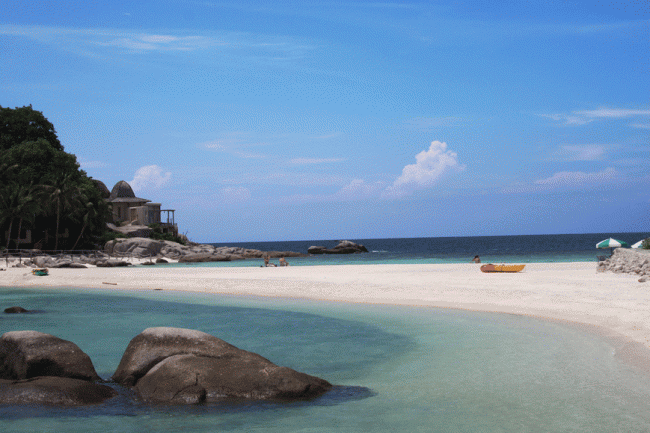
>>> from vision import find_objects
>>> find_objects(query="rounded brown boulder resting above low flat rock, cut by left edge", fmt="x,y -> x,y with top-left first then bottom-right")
0,331 -> 100,380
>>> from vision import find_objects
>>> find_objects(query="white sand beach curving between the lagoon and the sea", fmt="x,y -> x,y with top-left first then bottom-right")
0,263 -> 650,361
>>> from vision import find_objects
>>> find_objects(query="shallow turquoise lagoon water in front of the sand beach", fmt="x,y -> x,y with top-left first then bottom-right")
0,288 -> 650,432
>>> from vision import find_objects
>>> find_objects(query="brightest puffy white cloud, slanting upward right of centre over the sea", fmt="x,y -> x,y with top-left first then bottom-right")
382,141 -> 464,198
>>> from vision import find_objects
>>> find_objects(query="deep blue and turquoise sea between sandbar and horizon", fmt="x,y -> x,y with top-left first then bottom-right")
153,233 -> 650,267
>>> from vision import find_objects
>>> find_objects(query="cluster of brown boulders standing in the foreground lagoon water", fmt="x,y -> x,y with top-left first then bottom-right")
0,327 -> 332,406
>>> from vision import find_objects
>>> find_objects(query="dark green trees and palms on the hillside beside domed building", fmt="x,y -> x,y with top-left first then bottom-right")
0,107 -> 110,249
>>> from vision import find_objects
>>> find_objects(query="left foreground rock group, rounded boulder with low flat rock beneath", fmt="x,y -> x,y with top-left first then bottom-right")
0,331 -> 117,406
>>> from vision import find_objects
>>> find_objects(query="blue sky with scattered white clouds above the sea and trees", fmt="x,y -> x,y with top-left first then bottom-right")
0,0 -> 650,242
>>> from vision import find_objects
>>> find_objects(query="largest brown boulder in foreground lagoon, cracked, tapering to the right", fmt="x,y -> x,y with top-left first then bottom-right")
113,328 -> 332,404
